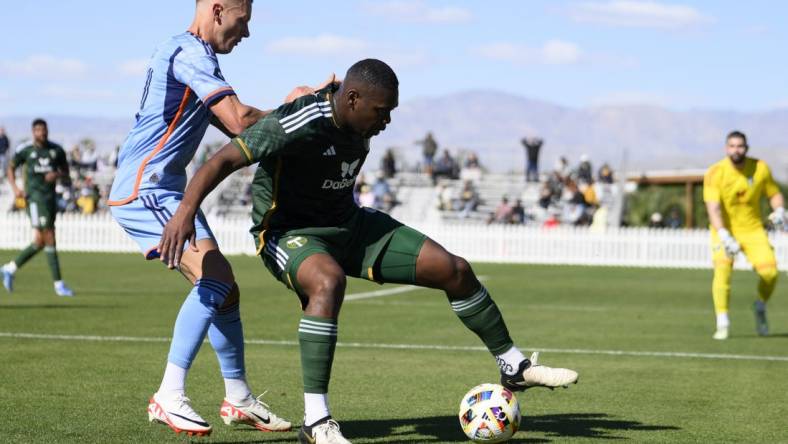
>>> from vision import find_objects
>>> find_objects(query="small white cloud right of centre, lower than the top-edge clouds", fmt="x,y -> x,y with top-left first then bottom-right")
471,40 -> 584,65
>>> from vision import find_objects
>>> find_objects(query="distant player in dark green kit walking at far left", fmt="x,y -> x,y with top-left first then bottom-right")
3,119 -> 74,296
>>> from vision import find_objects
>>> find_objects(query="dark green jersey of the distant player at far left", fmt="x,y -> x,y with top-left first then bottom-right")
11,142 -> 68,200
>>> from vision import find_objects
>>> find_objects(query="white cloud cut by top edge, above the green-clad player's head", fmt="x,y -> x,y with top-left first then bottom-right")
363,0 -> 473,23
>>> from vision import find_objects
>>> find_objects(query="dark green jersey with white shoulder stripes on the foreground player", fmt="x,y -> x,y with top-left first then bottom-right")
233,86 -> 369,250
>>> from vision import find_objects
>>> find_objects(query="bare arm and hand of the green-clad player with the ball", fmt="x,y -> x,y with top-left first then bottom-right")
158,143 -> 247,268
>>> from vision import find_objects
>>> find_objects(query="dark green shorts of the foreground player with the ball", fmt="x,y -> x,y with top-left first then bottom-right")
260,208 -> 427,302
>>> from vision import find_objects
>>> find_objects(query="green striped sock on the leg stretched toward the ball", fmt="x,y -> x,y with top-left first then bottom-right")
450,286 -> 514,356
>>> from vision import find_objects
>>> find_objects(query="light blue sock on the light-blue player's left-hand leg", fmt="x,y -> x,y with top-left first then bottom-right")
167,279 -> 230,369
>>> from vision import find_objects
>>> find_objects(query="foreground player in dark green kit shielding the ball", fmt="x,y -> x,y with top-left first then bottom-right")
159,59 -> 577,444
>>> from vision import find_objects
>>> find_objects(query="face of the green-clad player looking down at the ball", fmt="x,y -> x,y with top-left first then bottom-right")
349,88 -> 399,138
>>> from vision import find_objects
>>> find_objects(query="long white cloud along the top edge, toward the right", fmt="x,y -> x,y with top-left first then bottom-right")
566,0 -> 714,29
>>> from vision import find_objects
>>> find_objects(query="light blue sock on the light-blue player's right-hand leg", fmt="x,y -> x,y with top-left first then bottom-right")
208,286 -> 246,379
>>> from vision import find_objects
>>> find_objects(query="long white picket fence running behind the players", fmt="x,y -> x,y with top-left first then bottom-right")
0,213 -> 788,270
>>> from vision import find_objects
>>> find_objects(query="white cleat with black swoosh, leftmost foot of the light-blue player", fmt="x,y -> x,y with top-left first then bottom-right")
148,393 -> 212,436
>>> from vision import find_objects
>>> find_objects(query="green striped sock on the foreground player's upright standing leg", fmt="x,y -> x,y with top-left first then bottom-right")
298,315 -> 337,393
